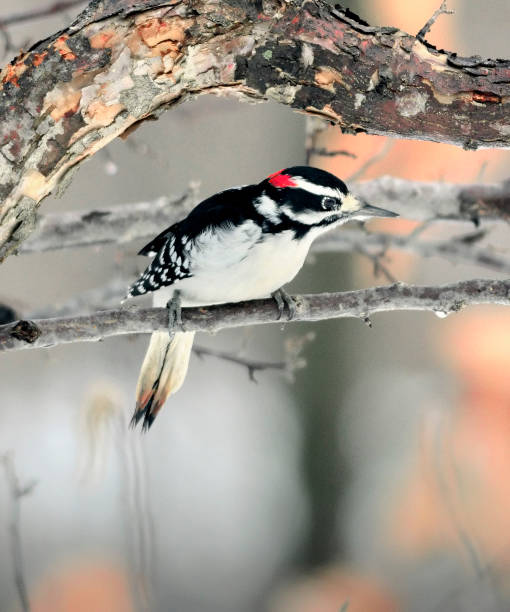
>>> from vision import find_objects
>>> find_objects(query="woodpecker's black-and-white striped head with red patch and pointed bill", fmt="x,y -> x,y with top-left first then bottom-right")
257,166 -> 398,226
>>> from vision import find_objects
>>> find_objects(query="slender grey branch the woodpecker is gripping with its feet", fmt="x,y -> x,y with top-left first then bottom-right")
0,279 -> 510,351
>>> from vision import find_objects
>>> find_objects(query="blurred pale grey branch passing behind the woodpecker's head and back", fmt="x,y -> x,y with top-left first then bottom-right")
19,176 -> 510,253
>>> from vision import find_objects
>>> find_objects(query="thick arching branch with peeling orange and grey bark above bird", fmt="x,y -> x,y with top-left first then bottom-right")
0,0 -> 510,259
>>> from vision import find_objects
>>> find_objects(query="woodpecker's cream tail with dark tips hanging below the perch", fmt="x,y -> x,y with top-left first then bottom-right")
131,332 -> 195,429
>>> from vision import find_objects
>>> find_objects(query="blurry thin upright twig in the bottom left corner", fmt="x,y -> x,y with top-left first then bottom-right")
1,453 -> 36,612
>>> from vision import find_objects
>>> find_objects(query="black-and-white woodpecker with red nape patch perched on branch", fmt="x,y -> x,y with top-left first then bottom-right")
128,166 -> 397,429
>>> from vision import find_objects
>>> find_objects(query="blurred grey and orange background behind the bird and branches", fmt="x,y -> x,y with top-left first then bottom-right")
0,0 -> 510,612
